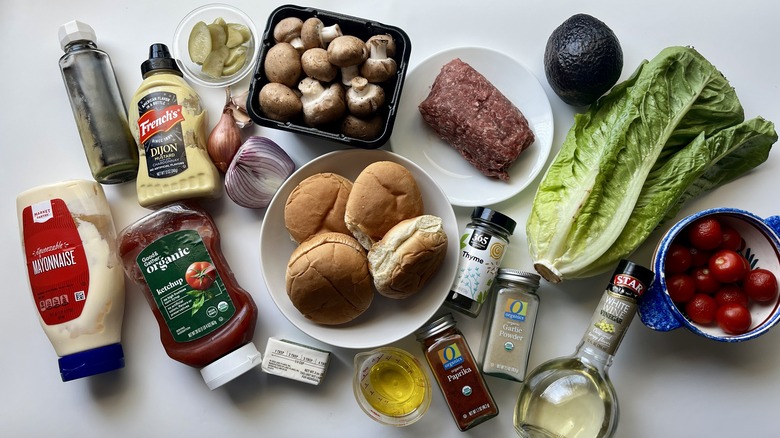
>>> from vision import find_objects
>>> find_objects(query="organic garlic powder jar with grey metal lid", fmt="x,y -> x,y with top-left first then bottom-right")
479,268 -> 541,382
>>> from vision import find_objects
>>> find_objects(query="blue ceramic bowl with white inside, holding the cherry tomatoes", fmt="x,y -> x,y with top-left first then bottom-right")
639,208 -> 780,342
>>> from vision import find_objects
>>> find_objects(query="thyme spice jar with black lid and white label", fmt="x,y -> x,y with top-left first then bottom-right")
444,207 -> 517,318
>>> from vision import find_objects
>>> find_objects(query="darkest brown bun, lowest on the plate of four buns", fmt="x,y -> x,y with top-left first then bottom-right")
285,232 -> 374,325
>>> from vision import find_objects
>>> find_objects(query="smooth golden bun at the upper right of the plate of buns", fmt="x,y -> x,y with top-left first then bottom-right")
344,161 -> 424,250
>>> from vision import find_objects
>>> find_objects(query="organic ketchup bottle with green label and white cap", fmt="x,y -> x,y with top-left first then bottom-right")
119,202 -> 261,389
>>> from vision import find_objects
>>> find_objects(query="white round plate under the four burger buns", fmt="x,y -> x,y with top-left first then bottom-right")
260,149 -> 458,349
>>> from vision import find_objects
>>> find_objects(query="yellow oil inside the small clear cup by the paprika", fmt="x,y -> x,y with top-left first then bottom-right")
362,360 -> 426,417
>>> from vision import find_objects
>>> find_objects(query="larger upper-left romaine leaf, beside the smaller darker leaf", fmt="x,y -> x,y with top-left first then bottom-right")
526,47 -> 756,282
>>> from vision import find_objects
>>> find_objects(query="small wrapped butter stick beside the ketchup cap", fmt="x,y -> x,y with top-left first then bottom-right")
262,338 -> 330,385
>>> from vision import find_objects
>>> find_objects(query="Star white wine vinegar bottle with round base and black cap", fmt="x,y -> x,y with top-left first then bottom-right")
514,260 -> 653,438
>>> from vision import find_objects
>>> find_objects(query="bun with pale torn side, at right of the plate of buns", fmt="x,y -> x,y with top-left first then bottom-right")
368,215 -> 447,299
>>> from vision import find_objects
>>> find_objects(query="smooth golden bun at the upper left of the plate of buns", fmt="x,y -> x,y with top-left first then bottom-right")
284,172 -> 352,243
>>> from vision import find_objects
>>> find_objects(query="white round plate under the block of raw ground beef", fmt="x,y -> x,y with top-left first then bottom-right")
390,47 -> 553,207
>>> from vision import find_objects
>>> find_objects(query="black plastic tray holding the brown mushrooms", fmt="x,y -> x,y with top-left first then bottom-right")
247,5 -> 412,149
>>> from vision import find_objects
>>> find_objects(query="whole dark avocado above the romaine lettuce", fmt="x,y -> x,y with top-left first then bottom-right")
544,14 -> 623,106
